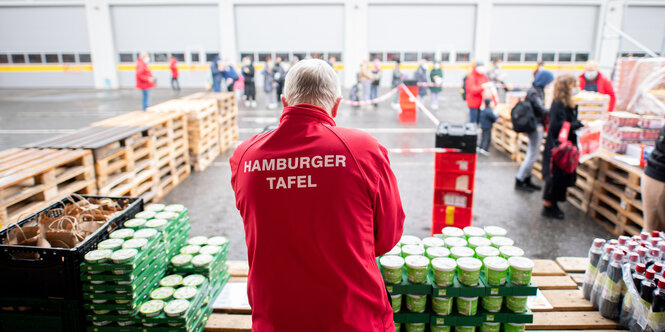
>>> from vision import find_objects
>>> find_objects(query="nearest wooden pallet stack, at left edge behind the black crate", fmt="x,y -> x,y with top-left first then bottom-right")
0,148 -> 97,228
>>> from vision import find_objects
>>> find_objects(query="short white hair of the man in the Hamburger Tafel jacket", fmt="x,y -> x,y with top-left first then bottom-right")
284,59 -> 342,112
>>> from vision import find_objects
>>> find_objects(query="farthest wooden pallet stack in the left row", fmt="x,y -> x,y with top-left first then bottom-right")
184,92 -> 238,153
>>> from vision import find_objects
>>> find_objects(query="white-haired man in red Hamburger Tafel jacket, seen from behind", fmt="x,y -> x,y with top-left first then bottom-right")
230,59 -> 404,332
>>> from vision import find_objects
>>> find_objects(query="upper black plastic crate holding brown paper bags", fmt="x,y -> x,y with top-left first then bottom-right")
0,195 -> 143,301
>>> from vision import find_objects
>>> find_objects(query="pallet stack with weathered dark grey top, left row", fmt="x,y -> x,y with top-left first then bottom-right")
27,126 -> 158,201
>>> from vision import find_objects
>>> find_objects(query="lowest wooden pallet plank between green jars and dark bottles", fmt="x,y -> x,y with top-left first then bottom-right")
526,311 -> 619,330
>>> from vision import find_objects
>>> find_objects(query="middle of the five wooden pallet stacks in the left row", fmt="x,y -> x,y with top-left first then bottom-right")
93,111 -> 191,200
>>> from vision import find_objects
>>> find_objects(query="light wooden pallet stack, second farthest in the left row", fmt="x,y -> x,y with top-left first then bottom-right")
148,99 -> 220,171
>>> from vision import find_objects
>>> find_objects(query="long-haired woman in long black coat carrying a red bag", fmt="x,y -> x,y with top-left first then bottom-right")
542,74 -> 584,219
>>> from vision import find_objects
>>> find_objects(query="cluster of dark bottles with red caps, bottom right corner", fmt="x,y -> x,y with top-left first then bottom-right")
582,231 -> 665,331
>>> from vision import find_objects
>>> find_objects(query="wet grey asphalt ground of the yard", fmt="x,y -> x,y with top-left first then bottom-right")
0,89 -> 610,259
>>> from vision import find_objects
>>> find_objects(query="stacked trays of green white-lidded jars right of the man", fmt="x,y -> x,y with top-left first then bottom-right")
378,226 -> 537,332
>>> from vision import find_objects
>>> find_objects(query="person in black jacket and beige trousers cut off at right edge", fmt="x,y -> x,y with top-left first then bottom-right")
642,127 -> 665,232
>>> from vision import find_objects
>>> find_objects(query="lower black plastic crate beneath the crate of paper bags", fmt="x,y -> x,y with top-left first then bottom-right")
0,298 -> 86,332
